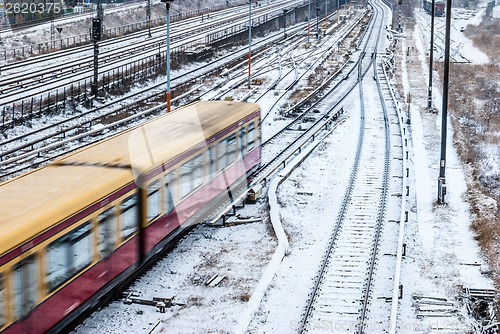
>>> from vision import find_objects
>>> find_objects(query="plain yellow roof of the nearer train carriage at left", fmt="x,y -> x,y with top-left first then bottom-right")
0,165 -> 132,256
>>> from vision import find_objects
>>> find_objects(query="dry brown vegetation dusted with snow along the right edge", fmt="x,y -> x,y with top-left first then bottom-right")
434,14 -> 500,298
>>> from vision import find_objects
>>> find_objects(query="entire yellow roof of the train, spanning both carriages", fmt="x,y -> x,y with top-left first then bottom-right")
0,101 -> 259,256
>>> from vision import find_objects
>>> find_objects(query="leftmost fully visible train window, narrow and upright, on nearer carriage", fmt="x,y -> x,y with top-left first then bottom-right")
12,255 -> 38,319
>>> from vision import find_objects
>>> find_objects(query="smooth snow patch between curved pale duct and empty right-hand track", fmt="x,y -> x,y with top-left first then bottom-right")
248,104 -> 359,333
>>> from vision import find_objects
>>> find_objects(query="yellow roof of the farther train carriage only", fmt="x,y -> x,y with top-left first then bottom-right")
58,101 -> 259,173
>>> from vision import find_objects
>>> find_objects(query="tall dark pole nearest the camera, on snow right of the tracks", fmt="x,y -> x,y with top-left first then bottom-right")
438,0 -> 451,204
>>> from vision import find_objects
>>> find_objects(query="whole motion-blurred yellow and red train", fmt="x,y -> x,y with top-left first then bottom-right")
0,101 -> 261,333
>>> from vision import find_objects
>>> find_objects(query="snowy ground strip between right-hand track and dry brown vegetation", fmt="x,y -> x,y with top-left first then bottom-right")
394,5 -> 493,332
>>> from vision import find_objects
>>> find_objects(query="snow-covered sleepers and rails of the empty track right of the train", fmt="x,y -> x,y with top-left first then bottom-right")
298,71 -> 390,333
